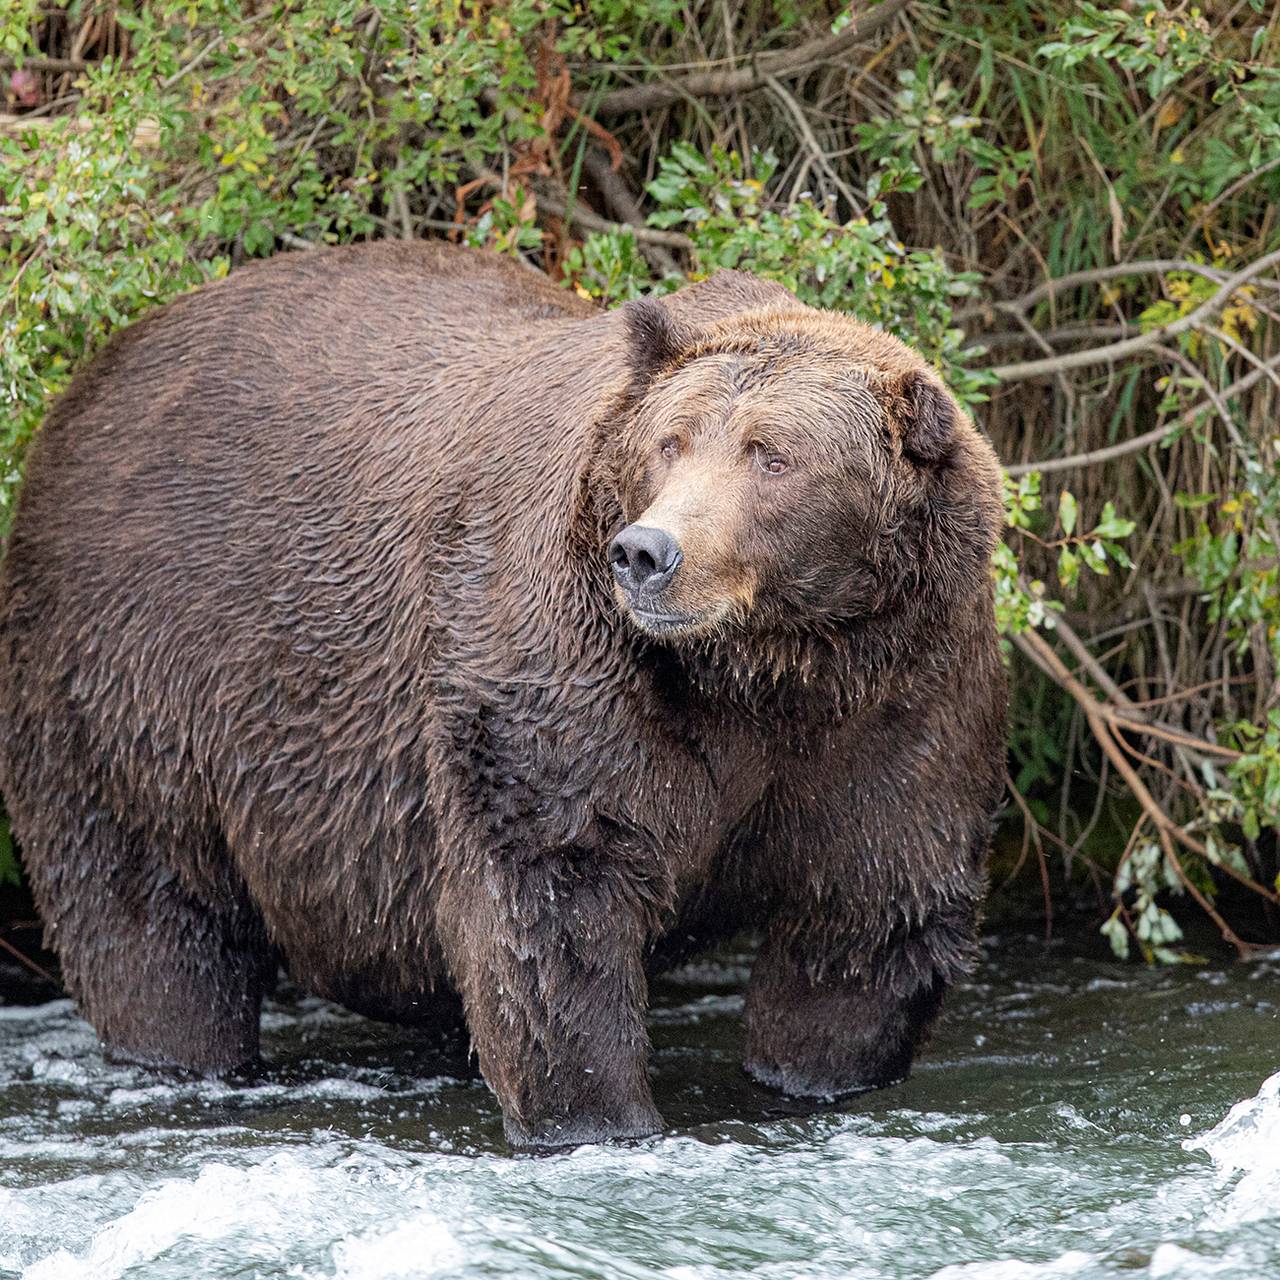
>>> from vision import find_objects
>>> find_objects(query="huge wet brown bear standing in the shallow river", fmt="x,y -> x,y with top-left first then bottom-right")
0,243 -> 1005,1146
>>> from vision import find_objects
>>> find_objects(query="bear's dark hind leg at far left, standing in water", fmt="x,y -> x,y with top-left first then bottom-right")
24,806 -> 274,1075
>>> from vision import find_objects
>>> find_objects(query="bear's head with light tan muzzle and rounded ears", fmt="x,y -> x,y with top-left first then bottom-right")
596,300 -> 1001,644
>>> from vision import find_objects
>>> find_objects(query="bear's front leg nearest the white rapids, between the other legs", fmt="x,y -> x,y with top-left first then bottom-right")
440,849 -> 662,1147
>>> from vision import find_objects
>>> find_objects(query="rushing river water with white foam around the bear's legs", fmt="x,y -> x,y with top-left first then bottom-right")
0,934 -> 1280,1280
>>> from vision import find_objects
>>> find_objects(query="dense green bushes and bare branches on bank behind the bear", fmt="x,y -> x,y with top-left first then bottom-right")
0,0 -> 1280,959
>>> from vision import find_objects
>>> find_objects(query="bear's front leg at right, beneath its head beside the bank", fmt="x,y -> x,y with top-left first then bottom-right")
745,678 -> 1004,1098
